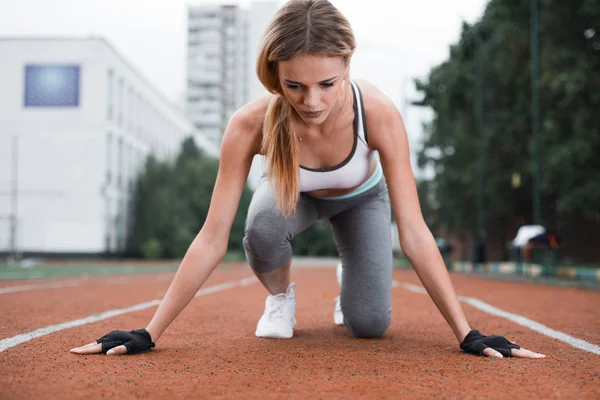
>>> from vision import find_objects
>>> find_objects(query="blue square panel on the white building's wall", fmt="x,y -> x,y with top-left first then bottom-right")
25,65 -> 80,107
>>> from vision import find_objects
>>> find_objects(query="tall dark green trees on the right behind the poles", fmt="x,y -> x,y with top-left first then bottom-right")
416,0 -> 600,250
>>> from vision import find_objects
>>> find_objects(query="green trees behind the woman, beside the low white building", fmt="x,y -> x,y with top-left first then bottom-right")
126,138 -> 337,259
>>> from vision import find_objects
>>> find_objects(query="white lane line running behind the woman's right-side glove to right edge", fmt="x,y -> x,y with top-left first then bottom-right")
392,281 -> 600,355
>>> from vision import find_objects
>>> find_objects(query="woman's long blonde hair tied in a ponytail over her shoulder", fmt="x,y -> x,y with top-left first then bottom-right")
256,0 -> 356,217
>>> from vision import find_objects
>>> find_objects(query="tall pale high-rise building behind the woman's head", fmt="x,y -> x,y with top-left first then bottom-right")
186,1 -> 278,146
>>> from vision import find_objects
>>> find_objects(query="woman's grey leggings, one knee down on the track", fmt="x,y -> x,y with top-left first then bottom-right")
244,178 -> 392,337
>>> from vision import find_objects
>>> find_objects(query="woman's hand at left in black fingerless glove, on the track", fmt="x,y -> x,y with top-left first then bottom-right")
71,329 -> 155,356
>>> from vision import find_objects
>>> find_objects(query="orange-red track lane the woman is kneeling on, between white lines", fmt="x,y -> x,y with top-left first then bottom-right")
0,268 -> 600,399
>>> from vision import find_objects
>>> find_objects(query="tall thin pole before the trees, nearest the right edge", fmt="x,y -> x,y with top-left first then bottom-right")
529,0 -> 542,225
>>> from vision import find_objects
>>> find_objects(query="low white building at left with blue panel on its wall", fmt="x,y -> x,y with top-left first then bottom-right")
0,37 -> 218,254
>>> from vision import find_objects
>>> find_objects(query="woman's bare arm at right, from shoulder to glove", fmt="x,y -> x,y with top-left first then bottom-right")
361,83 -> 471,342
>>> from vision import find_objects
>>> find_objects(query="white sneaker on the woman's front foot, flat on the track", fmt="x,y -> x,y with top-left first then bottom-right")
254,282 -> 296,339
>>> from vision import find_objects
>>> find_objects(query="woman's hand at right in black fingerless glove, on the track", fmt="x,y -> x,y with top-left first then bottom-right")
460,329 -> 546,358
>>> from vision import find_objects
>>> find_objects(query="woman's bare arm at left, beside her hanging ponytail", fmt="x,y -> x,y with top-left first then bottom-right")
71,103 -> 262,355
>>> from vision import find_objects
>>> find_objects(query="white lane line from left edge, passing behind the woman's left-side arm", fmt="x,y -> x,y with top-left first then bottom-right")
0,276 -> 258,353
